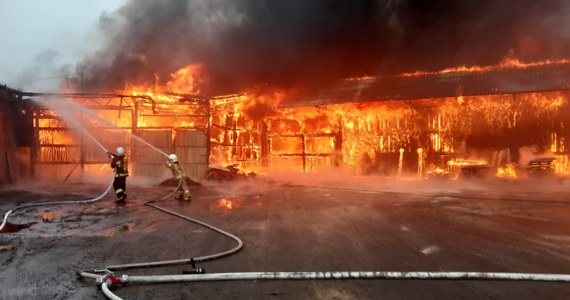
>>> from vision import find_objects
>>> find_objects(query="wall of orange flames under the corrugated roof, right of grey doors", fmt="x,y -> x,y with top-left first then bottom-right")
206,84 -> 567,173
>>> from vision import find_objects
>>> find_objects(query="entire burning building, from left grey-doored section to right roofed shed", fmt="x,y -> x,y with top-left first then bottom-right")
3,61 -> 570,179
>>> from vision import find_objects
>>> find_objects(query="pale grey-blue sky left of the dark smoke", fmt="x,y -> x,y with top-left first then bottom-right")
0,0 -> 126,91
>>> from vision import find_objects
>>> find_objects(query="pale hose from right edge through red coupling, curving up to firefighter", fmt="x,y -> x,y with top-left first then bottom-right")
78,187 -> 570,300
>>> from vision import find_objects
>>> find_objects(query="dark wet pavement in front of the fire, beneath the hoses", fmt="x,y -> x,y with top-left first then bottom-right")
0,178 -> 570,299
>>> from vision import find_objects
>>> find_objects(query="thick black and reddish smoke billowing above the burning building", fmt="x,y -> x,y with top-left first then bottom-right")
77,0 -> 570,94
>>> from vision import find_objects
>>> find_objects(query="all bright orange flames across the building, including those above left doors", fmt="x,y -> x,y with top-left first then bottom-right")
37,58 -> 570,177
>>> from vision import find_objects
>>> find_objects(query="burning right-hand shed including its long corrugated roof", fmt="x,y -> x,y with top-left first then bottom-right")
206,61 -> 570,176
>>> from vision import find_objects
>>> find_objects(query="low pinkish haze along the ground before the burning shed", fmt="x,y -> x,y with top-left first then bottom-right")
197,165 -> 570,201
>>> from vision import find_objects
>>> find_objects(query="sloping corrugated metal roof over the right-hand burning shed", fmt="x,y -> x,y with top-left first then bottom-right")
280,62 -> 570,107
